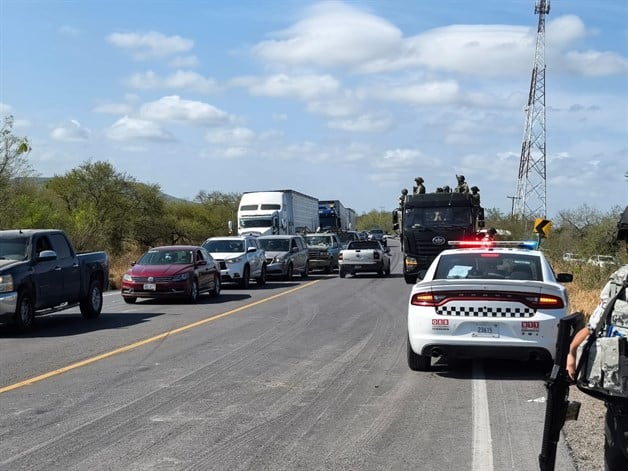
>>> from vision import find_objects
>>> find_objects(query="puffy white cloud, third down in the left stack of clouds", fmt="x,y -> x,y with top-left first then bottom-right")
140,95 -> 232,126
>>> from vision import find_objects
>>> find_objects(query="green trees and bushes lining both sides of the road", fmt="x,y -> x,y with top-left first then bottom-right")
0,116 -> 628,312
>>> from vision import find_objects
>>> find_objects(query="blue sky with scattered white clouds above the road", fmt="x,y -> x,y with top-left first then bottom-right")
0,0 -> 628,218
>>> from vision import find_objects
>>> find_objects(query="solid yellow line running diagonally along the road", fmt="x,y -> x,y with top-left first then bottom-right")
0,280 -> 320,394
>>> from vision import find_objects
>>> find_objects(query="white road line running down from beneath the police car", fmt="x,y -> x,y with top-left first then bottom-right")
471,361 -> 493,471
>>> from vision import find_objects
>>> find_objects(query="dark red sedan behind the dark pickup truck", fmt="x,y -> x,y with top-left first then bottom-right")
121,245 -> 220,304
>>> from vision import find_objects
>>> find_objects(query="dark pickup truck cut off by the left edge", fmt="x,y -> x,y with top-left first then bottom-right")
0,229 -> 109,332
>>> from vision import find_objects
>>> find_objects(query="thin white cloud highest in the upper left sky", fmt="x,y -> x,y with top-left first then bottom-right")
107,31 -> 194,59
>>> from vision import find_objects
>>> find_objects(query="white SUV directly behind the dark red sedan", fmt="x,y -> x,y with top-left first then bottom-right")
203,236 -> 266,288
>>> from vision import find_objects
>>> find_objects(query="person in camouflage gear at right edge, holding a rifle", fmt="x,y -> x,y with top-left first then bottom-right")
566,211 -> 628,471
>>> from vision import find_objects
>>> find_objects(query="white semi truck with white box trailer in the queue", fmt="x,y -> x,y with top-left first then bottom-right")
238,190 -> 319,236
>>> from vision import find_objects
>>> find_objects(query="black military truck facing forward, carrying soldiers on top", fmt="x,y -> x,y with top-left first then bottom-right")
392,192 -> 484,284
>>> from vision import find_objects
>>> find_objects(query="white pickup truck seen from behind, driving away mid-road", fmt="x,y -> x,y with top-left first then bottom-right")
338,240 -> 390,278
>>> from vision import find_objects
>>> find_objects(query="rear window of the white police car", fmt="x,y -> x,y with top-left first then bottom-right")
434,252 -> 543,280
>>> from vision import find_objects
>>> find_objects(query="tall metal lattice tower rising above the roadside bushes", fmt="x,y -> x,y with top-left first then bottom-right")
513,0 -> 550,219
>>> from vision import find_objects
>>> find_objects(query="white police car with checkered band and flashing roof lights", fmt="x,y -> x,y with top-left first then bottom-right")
408,241 -> 573,371
